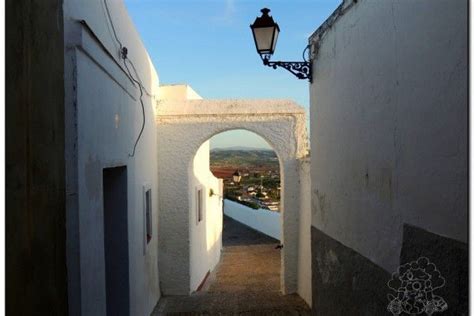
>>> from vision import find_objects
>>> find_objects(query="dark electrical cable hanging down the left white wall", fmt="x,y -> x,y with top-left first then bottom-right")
104,0 -> 152,157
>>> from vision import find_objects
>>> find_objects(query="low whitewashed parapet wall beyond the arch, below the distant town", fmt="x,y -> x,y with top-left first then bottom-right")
224,200 -> 281,240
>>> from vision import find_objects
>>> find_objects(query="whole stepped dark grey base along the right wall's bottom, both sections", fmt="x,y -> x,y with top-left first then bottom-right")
311,224 -> 469,316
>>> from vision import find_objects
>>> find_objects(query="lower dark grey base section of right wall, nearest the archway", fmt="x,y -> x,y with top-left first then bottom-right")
311,226 -> 390,316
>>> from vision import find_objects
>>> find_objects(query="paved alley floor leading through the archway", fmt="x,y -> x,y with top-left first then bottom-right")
152,216 -> 310,316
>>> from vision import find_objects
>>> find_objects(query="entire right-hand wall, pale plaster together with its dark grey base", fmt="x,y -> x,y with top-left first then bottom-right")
310,0 -> 468,315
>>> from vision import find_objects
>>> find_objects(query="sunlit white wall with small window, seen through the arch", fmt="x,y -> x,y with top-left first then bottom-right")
189,141 -> 223,291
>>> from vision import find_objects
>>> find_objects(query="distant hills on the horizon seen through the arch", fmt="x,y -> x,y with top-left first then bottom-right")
210,147 -> 278,168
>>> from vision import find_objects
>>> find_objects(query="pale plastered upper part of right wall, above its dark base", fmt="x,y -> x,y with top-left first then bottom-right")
310,0 -> 468,272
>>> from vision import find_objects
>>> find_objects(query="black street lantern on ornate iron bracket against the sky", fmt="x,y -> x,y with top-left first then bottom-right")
250,8 -> 312,82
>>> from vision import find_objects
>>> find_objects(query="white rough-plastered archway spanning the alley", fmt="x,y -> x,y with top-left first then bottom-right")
156,100 -> 308,295
